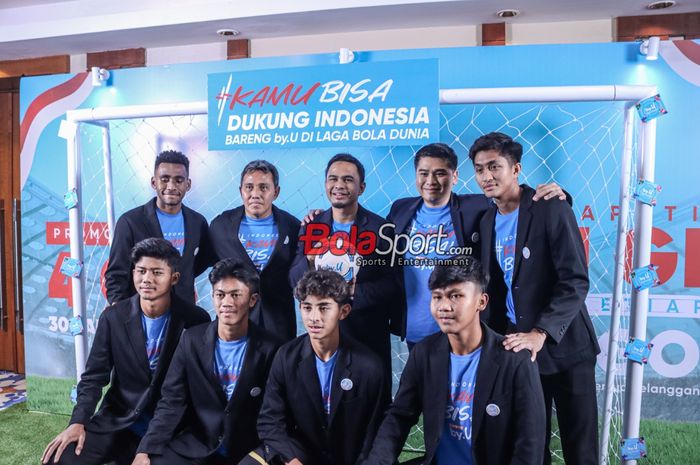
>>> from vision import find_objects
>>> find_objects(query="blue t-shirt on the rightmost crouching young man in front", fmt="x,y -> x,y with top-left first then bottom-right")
435,347 -> 481,465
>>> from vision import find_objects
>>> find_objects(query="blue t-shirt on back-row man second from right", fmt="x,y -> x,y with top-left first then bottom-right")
403,204 -> 457,343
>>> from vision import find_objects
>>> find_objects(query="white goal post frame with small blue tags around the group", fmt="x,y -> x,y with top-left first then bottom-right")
62,85 -> 657,465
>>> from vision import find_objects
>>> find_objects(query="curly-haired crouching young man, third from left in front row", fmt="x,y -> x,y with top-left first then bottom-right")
254,270 -> 389,465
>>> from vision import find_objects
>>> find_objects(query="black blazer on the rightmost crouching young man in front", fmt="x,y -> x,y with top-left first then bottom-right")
365,324 -> 546,465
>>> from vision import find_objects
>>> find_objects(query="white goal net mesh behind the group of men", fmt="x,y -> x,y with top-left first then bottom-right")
66,99 -> 629,463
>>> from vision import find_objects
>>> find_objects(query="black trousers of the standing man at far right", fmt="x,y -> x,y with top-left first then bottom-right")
540,360 -> 598,465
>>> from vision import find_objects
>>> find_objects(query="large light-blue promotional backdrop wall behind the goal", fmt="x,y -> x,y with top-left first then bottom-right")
20,41 -> 700,421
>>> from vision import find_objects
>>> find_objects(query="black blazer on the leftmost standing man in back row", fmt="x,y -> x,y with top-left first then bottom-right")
105,197 -> 211,303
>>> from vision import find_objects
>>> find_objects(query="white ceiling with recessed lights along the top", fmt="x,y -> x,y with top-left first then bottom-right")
0,0 -> 700,60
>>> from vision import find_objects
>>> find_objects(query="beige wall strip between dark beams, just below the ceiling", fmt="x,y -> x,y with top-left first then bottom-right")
71,19 -> 614,72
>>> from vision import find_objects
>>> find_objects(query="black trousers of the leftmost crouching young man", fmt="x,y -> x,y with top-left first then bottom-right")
53,429 -> 141,465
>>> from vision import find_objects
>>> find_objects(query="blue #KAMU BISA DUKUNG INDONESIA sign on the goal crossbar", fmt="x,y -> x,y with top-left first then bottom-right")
208,60 -> 440,150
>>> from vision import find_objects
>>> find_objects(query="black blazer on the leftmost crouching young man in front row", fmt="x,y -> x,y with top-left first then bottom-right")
70,294 -> 209,433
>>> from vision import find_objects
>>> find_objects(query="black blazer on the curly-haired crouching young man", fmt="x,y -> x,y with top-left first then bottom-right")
258,333 -> 389,465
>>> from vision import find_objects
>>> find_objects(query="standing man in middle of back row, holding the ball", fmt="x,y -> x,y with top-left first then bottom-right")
289,153 -> 398,380
